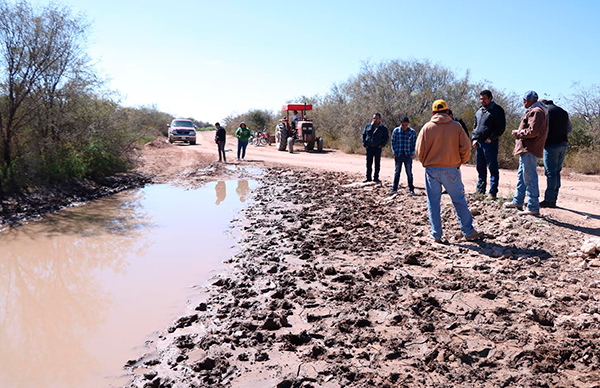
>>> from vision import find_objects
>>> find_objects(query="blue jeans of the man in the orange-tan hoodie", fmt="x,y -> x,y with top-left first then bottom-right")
425,167 -> 475,239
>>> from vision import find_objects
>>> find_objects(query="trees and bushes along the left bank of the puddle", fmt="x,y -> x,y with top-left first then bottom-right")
0,1 -> 173,195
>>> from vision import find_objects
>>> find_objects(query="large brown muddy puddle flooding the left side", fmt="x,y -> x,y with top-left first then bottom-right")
0,180 -> 256,388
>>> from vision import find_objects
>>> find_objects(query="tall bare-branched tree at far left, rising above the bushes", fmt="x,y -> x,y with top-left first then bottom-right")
0,1 -> 87,166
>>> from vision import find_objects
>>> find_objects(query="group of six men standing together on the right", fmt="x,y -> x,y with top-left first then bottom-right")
362,90 -> 572,242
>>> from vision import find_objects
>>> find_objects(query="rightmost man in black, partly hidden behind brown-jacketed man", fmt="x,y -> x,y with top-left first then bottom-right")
540,100 -> 573,207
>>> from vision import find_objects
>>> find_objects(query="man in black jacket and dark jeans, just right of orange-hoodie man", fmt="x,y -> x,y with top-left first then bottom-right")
472,89 -> 506,199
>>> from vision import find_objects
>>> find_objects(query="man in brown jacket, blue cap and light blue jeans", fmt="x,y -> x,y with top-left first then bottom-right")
504,90 -> 548,215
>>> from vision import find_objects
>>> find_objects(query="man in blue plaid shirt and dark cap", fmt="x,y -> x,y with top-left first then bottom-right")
390,117 -> 417,195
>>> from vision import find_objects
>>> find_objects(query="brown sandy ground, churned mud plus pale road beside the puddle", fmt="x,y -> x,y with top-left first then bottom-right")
126,133 -> 600,388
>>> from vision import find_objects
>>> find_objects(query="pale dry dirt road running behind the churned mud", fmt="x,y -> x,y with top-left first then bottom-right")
150,132 -> 600,235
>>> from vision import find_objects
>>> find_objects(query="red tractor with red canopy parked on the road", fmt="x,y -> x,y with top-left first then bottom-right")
275,104 -> 323,153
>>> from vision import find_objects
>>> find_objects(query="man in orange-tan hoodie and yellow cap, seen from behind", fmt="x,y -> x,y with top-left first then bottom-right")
416,100 -> 479,242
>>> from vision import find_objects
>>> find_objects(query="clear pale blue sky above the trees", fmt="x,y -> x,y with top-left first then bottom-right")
27,0 -> 600,121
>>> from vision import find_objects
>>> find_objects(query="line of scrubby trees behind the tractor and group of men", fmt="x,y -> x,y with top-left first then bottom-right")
225,59 -> 600,174
